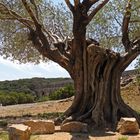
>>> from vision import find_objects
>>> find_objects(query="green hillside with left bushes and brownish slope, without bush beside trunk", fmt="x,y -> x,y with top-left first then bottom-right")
0,78 -> 72,105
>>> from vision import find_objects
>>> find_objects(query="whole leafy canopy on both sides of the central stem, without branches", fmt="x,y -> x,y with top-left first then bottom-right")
0,0 -> 140,63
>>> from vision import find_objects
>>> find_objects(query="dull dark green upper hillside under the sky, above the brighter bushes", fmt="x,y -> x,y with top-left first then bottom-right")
0,78 -> 69,94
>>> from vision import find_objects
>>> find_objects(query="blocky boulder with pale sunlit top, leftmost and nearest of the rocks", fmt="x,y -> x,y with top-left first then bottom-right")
8,124 -> 31,140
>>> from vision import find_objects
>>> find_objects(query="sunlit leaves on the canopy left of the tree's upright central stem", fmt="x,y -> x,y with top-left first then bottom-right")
0,0 -> 71,63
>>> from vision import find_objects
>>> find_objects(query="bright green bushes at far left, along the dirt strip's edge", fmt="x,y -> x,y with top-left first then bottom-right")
0,92 -> 34,106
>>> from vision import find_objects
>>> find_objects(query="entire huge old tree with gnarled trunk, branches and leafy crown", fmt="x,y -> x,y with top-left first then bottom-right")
0,0 -> 140,128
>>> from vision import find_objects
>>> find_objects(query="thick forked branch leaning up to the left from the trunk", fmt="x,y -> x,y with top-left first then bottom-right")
0,0 -> 72,73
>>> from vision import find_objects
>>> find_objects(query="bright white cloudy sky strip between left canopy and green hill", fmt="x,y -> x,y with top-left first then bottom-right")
0,57 -> 69,81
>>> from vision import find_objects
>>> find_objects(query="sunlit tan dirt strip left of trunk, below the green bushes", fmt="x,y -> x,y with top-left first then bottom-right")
0,99 -> 72,117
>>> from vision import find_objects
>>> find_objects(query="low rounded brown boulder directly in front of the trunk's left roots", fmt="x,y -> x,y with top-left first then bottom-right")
61,121 -> 88,133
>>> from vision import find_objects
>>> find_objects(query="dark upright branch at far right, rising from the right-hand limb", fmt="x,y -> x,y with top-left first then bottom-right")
122,0 -> 131,52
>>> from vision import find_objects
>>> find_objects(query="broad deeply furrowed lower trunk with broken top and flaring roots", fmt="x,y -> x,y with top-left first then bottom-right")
64,45 -> 140,128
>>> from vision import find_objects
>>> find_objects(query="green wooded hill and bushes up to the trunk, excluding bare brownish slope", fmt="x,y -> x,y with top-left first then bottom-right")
0,78 -> 74,105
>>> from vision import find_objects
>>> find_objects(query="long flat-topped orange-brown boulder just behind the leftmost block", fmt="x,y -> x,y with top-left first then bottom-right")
24,120 -> 55,134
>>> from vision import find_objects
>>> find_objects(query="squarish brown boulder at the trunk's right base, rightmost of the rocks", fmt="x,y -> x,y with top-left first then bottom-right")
117,118 -> 139,134
